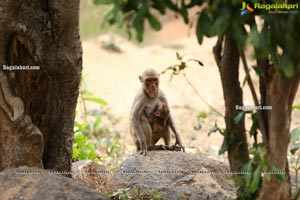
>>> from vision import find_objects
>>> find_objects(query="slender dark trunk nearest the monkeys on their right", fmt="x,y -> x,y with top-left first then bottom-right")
214,33 -> 249,171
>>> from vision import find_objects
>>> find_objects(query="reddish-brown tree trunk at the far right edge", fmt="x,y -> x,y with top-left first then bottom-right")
259,69 -> 300,200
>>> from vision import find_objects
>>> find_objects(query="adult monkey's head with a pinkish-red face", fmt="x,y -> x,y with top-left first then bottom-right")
139,68 -> 159,98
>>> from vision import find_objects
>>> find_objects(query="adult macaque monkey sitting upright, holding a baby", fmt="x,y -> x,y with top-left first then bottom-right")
130,69 -> 184,155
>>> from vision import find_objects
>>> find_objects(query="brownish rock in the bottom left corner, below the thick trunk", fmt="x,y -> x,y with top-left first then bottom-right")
0,167 -> 110,200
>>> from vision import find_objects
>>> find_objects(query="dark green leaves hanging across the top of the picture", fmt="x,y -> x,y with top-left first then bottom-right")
94,0 -> 300,74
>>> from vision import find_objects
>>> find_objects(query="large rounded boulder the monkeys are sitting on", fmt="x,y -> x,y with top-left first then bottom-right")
106,151 -> 235,200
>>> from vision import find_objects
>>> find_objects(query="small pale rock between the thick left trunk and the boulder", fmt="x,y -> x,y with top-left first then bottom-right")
72,160 -> 111,190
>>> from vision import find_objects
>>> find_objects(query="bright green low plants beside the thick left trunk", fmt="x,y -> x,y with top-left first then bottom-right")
73,76 -> 122,166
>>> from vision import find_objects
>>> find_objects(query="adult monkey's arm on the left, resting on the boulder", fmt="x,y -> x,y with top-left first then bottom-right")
131,98 -> 148,155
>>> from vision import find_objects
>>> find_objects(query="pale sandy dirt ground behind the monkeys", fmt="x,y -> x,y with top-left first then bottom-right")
83,16 -> 300,161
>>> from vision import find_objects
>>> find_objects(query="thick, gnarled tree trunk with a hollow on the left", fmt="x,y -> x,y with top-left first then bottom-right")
0,0 -> 82,171
